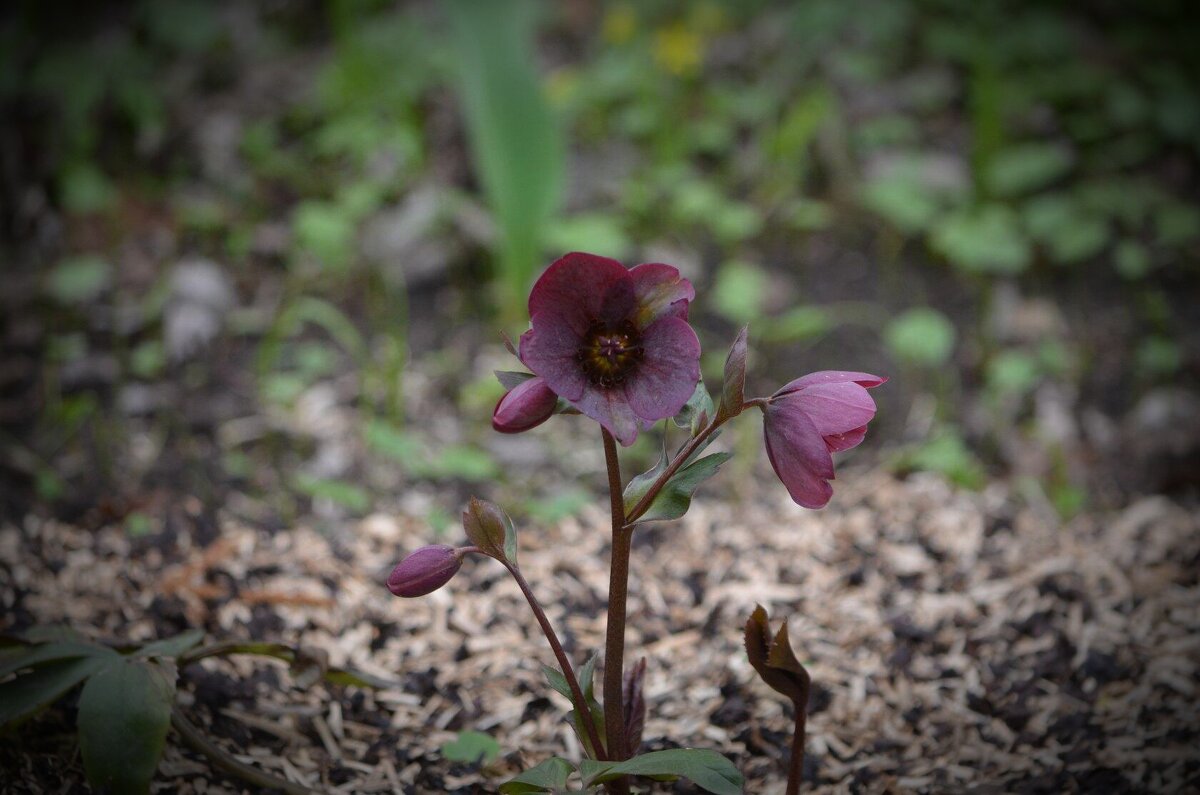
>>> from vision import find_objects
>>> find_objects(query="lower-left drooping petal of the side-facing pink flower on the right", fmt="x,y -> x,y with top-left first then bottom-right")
762,402 -> 834,508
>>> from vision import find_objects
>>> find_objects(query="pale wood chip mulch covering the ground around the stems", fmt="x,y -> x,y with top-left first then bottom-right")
0,472 -> 1200,794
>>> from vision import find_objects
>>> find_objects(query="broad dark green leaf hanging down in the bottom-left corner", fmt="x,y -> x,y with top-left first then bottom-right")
79,657 -> 175,795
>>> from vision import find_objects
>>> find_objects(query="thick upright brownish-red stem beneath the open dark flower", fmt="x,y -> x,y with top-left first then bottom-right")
600,429 -> 634,795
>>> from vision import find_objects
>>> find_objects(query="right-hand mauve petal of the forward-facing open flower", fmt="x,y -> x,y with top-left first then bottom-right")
625,315 -> 700,422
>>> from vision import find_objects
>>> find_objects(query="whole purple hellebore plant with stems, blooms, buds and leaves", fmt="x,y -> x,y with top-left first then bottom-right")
388,252 -> 887,794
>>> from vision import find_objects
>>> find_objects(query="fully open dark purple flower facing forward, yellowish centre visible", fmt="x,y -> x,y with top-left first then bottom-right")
518,252 -> 700,447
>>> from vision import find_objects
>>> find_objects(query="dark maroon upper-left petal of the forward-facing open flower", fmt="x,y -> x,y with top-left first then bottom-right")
529,251 -> 635,336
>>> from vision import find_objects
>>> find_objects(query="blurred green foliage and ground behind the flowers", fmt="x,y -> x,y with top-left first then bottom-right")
0,0 -> 1200,516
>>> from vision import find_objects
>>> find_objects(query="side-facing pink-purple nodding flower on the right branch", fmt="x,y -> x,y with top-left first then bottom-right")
762,370 -> 887,508
